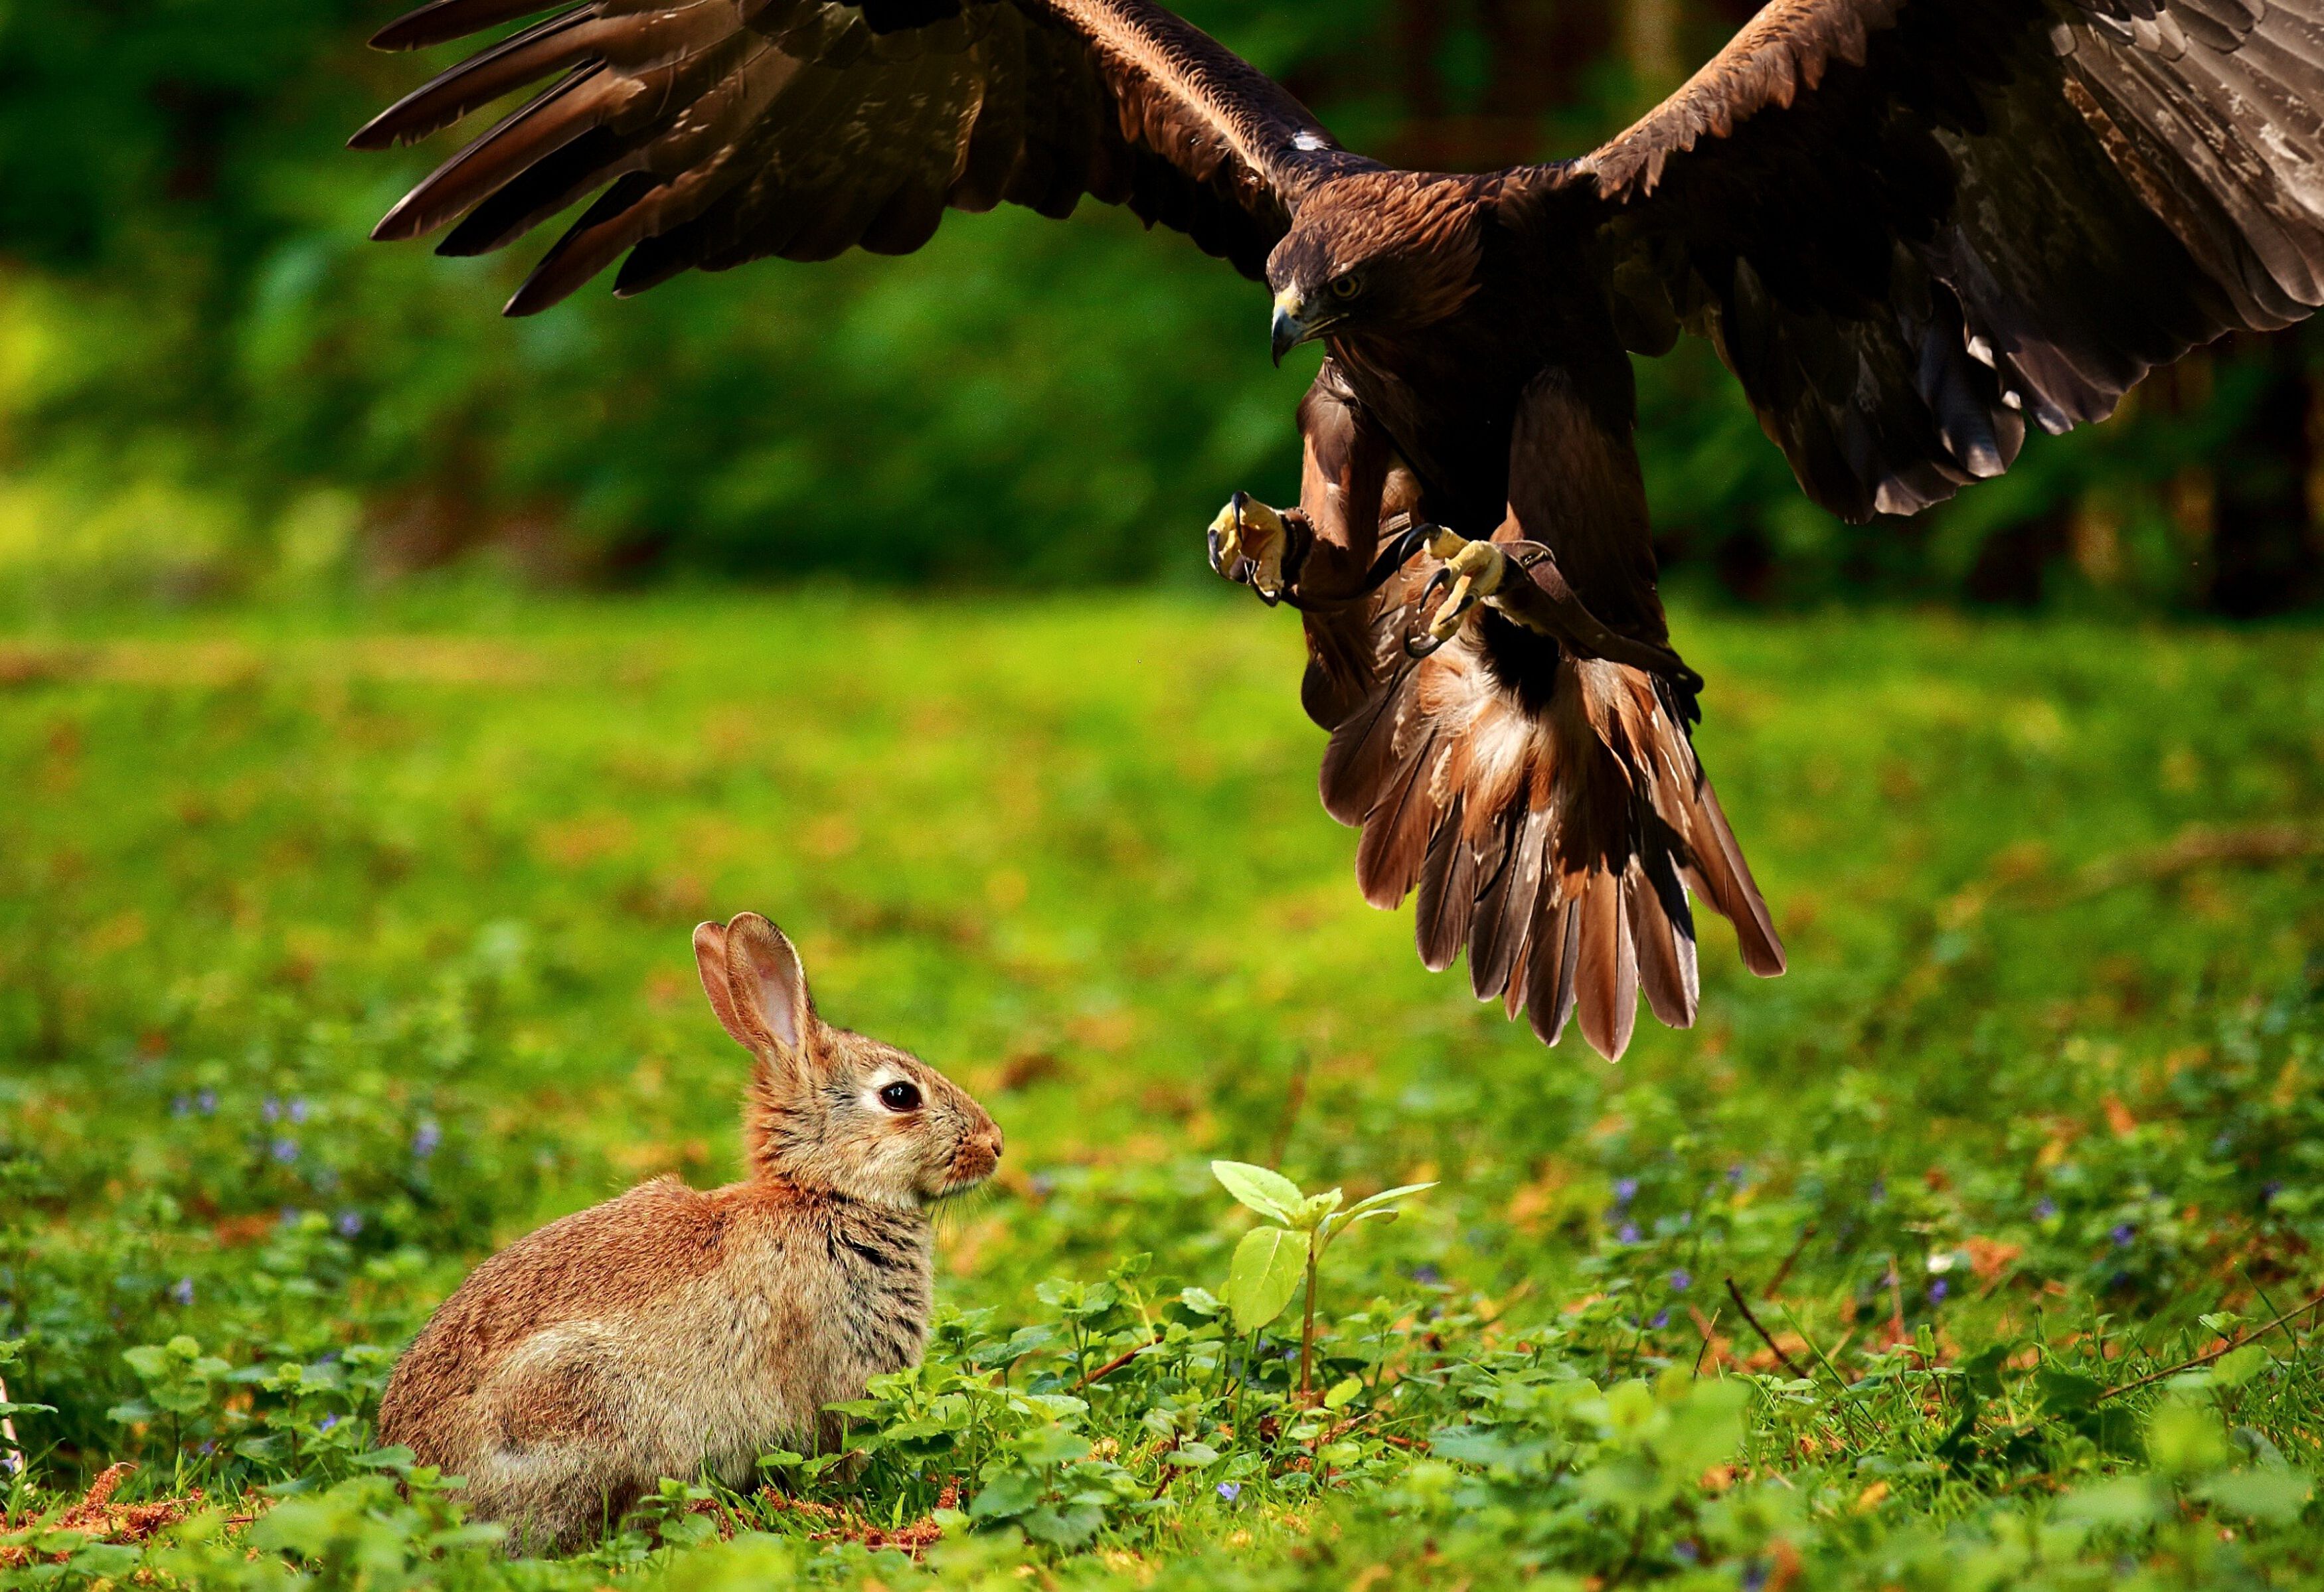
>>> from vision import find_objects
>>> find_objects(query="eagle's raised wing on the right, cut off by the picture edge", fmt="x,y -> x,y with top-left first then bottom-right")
1515,0 -> 2324,520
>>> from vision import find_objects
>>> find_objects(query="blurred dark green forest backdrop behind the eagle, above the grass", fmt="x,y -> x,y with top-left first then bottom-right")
0,0 -> 2324,616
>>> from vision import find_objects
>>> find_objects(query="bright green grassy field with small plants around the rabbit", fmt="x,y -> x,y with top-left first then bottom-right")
0,593 -> 2324,1592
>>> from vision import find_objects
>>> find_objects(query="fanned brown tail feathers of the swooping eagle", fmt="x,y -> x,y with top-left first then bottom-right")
1323,621 -> 1783,1058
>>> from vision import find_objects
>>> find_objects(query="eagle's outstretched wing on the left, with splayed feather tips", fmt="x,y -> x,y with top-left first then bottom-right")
353,0 -> 1369,314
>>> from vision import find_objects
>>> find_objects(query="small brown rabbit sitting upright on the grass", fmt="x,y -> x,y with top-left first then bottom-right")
379,914 -> 1002,1550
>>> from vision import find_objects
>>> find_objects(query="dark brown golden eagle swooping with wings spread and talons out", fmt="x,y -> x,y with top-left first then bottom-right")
353,0 -> 2324,1058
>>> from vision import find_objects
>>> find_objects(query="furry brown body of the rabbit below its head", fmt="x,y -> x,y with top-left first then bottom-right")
379,1178 -> 930,1538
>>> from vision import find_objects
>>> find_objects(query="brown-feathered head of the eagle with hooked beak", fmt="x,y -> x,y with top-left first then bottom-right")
1267,172 -> 1485,365
